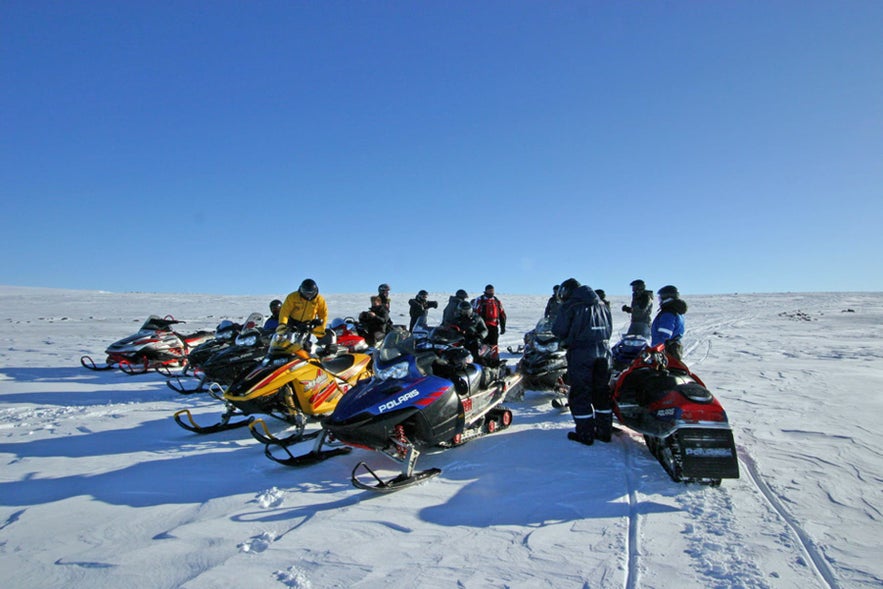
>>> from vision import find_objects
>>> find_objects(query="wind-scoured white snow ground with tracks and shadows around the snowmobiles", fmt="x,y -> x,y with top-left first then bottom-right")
0,285 -> 883,589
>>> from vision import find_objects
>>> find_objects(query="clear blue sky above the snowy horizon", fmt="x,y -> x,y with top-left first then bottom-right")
0,0 -> 883,296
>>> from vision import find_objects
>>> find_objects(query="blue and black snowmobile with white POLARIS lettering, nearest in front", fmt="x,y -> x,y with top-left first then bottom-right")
265,316 -> 521,493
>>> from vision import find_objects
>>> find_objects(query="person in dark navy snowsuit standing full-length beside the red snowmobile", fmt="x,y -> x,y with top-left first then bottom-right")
552,278 -> 613,445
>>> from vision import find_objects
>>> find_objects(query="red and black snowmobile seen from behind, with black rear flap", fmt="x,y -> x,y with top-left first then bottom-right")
613,344 -> 739,486
